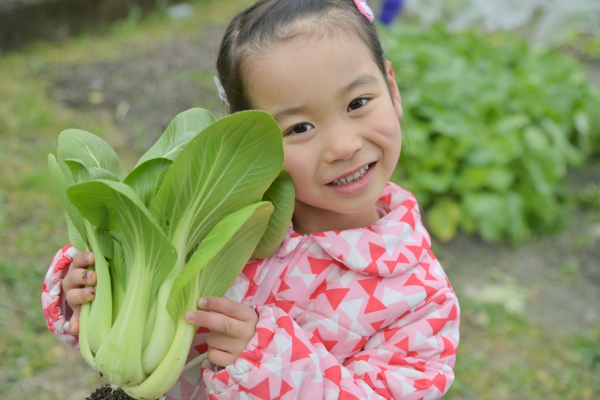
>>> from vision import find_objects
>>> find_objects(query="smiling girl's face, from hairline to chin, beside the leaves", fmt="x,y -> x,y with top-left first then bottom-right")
247,36 -> 402,231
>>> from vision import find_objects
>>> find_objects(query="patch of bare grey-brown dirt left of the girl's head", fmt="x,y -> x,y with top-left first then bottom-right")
46,26 -> 226,152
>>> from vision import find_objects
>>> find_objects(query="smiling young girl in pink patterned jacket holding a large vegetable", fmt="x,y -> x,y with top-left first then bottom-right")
43,0 -> 459,400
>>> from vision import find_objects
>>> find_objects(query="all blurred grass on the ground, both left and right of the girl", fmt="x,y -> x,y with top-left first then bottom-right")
0,0 -> 600,400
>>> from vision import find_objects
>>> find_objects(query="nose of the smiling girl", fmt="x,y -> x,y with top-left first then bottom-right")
321,122 -> 364,164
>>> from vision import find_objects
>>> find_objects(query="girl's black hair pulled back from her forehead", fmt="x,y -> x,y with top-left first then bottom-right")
217,0 -> 387,113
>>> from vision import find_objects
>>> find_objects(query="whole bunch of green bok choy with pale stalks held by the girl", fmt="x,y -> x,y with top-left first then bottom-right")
48,109 -> 294,399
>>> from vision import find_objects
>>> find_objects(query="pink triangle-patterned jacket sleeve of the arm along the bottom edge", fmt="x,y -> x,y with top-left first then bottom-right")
202,287 -> 459,400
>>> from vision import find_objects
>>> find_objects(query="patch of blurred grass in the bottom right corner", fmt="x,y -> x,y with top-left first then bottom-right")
446,297 -> 600,400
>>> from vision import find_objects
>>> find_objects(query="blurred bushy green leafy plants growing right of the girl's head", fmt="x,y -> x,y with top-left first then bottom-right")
383,25 -> 600,242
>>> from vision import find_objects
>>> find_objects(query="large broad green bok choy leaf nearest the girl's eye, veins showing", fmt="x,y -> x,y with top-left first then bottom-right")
151,111 -> 283,253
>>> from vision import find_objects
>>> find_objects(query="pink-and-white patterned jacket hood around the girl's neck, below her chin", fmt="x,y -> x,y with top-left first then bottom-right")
277,182 -> 431,277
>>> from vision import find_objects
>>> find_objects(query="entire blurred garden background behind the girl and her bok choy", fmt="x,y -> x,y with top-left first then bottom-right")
0,0 -> 600,400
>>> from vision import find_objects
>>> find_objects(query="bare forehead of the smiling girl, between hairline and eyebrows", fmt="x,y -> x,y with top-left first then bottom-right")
245,35 -> 382,111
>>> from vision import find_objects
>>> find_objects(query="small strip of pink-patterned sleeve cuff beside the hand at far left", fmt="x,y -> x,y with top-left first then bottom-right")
42,245 -> 79,349
